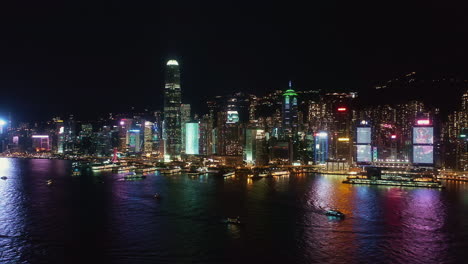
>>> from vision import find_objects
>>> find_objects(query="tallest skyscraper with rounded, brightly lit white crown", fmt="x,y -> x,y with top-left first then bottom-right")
163,60 -> 182,159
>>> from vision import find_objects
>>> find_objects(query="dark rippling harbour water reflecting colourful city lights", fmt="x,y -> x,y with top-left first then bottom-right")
0,158 -> 468,264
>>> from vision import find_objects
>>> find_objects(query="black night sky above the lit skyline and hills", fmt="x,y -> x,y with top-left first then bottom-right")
0,0 -> 468,120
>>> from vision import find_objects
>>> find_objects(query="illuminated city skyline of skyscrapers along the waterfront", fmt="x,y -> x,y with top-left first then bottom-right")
0,64 -> 468,170
